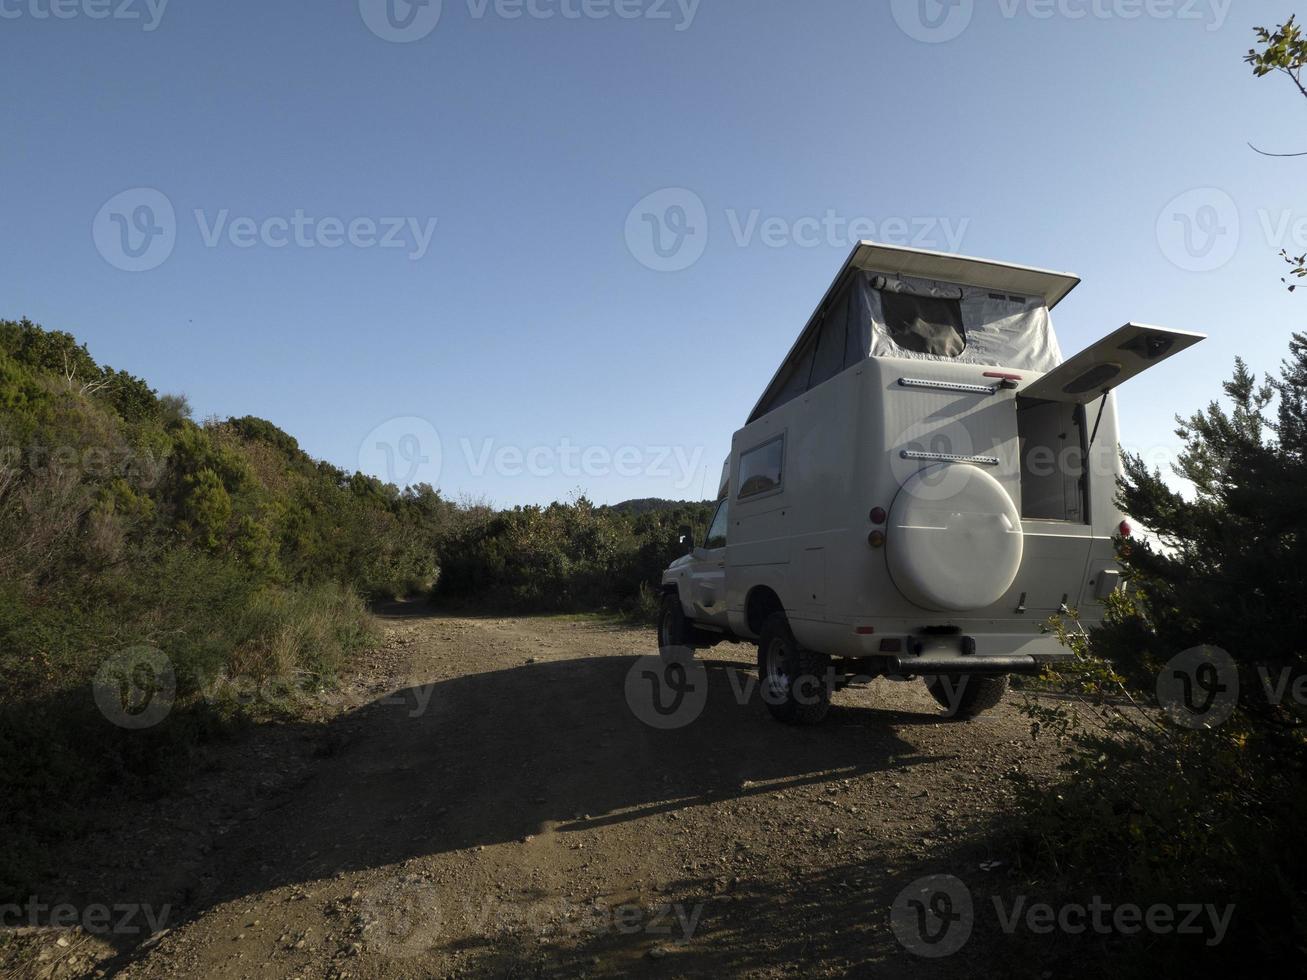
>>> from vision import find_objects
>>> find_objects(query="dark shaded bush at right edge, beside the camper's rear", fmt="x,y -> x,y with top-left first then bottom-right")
1019,335 -> 1307,976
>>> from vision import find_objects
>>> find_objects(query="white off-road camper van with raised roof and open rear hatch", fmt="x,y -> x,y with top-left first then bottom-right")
659,242 -> 1202,724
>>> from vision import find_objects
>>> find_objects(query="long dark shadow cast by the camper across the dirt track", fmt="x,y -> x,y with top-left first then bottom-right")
40,610 -> 967,968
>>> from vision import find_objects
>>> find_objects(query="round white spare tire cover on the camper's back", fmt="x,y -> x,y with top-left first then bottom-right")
885,463 -> 1023,612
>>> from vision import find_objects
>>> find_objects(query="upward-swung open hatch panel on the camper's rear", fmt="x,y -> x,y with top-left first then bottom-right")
1021,323 -> 1206,405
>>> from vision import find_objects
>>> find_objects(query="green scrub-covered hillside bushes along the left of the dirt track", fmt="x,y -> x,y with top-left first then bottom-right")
0,320 -> 707,902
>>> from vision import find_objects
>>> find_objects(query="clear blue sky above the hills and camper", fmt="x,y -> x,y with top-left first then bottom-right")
0,0 -> 1307,504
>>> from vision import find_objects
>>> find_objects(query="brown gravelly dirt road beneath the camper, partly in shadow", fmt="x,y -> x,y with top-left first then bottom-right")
12,606 -> 1071,977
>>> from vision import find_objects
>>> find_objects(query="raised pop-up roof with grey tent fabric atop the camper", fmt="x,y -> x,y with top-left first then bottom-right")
749,242 -> 1080,422
